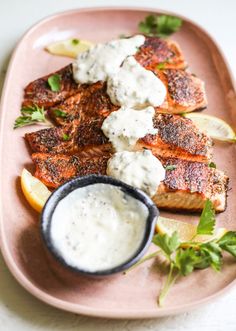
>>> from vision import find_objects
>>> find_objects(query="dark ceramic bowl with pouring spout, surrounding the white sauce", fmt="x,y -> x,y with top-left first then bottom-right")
41,175 -> 159,276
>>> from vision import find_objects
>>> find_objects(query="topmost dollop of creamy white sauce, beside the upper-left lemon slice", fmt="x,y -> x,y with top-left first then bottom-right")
73,35 -> 145,84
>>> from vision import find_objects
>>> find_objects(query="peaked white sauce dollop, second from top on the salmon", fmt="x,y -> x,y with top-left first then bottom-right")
107,56 -> 166,108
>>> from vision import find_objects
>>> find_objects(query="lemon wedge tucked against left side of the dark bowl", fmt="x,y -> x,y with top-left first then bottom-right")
21,169 -> 51,212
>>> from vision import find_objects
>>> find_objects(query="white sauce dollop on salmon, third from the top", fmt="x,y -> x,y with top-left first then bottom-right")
102,107 -> 157,152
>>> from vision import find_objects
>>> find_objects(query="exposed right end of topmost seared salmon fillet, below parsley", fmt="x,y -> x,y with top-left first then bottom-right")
135,37 -> 187,70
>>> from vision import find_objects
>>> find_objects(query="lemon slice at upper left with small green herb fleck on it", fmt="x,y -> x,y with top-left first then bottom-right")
46,38 -> 93,58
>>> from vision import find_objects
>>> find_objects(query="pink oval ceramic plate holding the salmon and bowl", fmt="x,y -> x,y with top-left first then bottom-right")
0,8 -> 236,318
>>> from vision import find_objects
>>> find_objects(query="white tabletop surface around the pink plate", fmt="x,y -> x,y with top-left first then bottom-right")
0,0 -> 236,331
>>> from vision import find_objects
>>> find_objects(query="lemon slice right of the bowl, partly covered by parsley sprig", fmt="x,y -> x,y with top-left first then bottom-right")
156,216 -> 226,243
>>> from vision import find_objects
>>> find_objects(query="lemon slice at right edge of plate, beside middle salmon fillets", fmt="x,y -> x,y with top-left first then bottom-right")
184,113 -> 236,142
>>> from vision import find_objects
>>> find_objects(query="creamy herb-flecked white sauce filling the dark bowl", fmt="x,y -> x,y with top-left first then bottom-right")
50,184 -> 148,272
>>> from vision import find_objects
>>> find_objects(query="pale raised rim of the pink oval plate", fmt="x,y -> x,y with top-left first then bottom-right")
0,6 -> 236,319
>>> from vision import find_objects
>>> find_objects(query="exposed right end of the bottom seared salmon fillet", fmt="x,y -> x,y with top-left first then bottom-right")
155,158 -> 229,212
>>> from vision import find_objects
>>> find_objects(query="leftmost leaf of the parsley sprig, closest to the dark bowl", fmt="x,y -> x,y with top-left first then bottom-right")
152,231 -> 180,259
